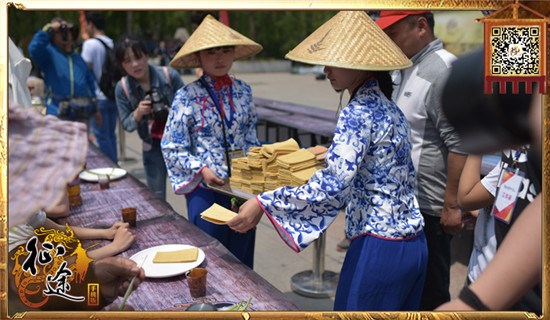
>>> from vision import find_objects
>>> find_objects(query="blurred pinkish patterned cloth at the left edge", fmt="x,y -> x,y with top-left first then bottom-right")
8,101 -> 88,227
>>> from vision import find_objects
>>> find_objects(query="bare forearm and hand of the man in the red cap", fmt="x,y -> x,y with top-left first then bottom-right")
440,151 -> 466,235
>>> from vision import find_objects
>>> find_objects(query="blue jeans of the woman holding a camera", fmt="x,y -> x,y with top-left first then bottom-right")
142,139 -> 168,200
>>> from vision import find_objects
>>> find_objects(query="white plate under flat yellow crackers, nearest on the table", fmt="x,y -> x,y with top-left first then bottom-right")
130,244 -> 205,278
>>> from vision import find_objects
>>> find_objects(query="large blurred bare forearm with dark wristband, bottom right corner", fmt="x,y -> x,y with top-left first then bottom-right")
436,194 -> 542,311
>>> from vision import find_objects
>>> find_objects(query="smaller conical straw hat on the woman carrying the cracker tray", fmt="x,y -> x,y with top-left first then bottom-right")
170,15 -> 263,68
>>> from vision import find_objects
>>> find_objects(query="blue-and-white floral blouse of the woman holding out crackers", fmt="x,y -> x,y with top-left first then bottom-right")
256,80 -> 423,252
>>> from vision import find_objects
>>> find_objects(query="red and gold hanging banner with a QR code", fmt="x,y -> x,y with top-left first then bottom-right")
478,0 -> 549,94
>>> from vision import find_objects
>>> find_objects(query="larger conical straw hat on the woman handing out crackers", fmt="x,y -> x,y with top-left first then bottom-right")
285,11 -> 412,71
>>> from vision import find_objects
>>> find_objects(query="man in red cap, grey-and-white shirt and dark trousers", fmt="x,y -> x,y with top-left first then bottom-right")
376,10 -> 466,310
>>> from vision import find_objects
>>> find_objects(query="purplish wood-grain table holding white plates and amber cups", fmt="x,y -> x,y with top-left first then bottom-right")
59,146 -> 297,311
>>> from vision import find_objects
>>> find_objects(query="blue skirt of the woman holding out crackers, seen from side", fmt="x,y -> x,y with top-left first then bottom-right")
334,233 -> 428,311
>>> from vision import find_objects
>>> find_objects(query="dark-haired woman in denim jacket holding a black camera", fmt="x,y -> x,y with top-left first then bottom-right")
115,36 -> 183,199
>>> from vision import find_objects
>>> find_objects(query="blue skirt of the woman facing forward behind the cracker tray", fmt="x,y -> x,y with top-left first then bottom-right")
186,187 -> 256,269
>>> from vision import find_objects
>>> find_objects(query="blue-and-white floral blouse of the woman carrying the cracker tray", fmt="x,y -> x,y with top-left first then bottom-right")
161,75 -> 259,194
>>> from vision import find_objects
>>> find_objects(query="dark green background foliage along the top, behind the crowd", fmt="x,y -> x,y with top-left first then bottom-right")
8,6 -> 336,59
